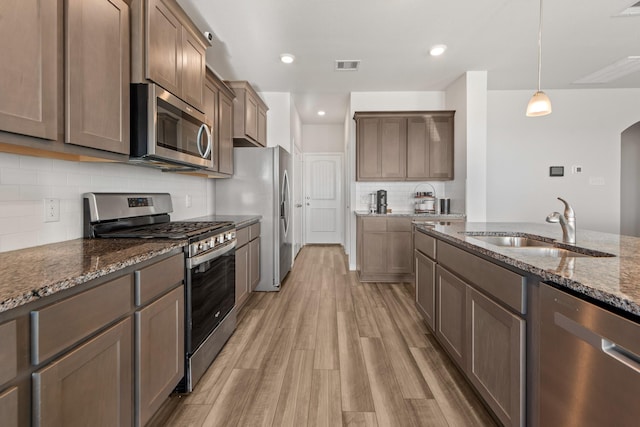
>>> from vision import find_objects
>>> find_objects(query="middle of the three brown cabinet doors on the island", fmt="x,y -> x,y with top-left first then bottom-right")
436,266 -> 467,369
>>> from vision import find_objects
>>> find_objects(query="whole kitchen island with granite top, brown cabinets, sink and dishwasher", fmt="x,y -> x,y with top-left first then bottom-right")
414,222 -> 640,426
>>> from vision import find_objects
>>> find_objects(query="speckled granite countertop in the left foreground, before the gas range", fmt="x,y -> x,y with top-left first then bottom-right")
0,239 -> 186,313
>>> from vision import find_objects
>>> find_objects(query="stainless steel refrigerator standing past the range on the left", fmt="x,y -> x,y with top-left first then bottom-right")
215,146 -> 293,292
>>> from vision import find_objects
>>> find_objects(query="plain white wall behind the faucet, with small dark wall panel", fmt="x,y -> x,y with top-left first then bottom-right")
487,89 -> 640,234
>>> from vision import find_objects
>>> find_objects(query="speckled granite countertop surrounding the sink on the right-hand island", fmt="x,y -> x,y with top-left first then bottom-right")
418,222 -> 640,316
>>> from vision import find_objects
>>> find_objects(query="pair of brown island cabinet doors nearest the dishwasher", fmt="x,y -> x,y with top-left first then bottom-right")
432,264 -> 526,426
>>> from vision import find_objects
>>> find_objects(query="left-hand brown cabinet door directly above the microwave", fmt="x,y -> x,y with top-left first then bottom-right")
145,0 -> 183,96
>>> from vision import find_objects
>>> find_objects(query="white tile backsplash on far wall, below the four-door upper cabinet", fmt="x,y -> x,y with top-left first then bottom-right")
355,182 -> 446,212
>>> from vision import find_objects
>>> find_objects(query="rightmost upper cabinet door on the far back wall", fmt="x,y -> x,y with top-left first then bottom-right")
428,115 -> 453,180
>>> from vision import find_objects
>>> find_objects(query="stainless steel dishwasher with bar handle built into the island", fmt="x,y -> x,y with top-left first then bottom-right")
538,284 -> 640,427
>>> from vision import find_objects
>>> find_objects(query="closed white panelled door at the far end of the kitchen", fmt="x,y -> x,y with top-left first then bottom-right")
304,153 -> 344,243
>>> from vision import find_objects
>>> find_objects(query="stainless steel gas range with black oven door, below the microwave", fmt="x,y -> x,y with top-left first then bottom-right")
83,193 -> 236,393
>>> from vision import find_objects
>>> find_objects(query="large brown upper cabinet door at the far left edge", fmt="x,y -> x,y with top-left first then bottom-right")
0,0 -> 57,140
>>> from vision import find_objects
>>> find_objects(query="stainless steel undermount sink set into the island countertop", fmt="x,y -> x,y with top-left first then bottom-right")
462,231 -> 615,258
